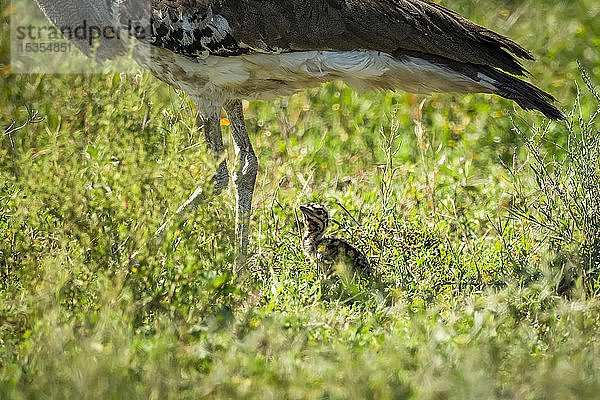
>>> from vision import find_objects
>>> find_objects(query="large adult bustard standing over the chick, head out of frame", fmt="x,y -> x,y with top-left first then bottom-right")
36,0 -> 563,267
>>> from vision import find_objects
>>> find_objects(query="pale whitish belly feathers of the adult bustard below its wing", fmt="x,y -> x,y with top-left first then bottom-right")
134,44 -> 494,115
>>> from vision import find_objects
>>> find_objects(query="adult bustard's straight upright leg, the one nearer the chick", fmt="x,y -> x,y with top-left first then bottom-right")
224,100 -> 258,273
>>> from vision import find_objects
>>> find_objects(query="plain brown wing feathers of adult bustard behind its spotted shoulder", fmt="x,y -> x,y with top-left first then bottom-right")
214,0 -> 533,75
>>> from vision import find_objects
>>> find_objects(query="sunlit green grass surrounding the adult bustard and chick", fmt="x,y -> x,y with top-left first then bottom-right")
0,0 -> 600,399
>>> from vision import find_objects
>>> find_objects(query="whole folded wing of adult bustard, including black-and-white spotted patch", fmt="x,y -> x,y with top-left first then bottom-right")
115,0 -> 533,75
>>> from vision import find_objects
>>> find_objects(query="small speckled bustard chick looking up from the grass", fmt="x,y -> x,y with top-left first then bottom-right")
300,203 -> 373,277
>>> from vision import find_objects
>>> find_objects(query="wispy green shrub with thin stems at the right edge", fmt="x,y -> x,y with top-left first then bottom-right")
506,67 -> 600,294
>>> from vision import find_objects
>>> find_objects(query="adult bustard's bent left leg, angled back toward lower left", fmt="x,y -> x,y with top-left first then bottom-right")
156,108 -> 229,240
